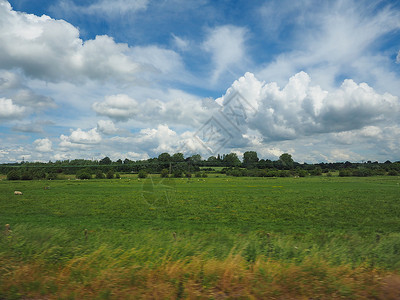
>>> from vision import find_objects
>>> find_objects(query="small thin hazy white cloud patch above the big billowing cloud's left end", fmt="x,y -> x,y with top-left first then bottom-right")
203,25 -> 247,82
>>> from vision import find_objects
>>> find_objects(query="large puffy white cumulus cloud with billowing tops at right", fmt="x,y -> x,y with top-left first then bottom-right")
217,72 -> 400,141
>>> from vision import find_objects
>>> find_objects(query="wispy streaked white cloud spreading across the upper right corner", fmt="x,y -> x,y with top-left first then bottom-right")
257,1 -> 400,93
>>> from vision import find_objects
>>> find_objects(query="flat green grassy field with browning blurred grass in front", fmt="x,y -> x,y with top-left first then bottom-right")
0,175 -> 400,299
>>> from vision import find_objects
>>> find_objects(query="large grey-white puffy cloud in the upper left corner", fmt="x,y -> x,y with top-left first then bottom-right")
0,0 -> 140,82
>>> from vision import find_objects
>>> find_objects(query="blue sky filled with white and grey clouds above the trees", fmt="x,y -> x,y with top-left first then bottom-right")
0,0 -> 400,163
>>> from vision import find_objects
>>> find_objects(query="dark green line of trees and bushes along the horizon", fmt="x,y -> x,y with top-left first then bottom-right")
0,151 -> 400,180
